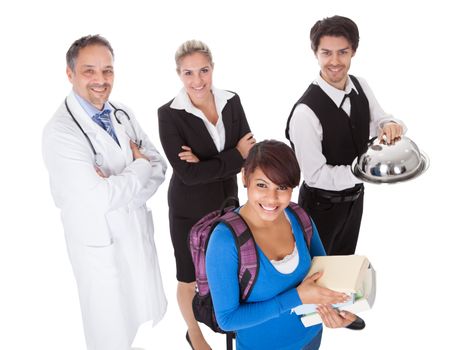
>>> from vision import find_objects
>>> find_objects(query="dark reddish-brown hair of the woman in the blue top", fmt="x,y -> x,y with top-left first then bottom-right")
243,140 -> 300,188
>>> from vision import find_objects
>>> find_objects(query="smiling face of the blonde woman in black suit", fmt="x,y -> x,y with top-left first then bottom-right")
179,52 -> 213,105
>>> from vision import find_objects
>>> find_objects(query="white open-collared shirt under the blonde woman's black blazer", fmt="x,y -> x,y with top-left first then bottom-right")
170,87 -> 234,152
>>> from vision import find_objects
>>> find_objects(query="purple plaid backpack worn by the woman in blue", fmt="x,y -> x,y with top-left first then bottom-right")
189,197 -> 312,334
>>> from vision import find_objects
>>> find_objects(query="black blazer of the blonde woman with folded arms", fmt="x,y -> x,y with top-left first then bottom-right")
158,94 -> 250,219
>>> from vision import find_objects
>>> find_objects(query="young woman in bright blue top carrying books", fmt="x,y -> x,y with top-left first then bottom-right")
206,140 -> 356,350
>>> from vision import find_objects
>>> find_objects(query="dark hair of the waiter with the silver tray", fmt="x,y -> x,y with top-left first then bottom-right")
309,16 -> 359,53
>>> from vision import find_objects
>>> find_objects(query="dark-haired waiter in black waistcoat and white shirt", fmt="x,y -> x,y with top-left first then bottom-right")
286,16 -> 405,255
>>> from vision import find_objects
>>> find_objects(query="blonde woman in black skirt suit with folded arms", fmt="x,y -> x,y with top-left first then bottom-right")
158,40 -> 256,350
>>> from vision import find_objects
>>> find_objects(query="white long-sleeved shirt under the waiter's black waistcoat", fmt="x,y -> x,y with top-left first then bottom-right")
289,75 -> 406,191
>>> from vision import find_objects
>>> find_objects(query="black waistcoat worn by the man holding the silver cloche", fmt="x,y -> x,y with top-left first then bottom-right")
286,75 -> 370,166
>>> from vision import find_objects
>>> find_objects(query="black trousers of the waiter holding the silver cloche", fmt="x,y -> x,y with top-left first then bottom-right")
298,183 -> 364,255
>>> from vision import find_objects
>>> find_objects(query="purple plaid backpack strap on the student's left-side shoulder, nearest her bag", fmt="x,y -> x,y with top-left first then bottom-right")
220,211 -> 259,301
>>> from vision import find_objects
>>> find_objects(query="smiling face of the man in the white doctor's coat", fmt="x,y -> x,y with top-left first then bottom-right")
66,44 -> 114,110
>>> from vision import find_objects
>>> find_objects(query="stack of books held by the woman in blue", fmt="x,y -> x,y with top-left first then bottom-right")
292,255 -> 377,327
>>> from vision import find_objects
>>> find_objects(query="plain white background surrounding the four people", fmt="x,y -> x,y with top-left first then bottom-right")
0,0 -> 452,350
